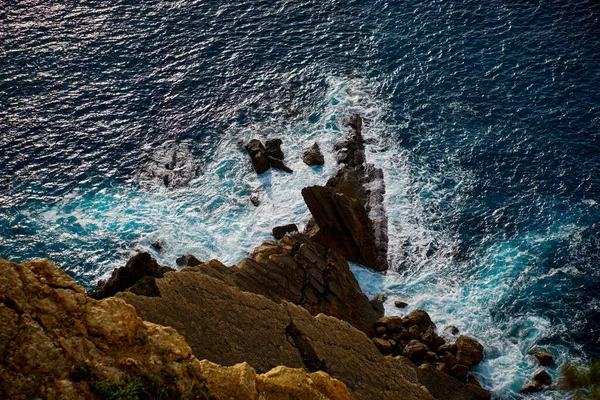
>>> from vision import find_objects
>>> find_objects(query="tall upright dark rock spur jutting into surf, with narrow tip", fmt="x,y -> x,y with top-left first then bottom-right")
302,115 -> 388,271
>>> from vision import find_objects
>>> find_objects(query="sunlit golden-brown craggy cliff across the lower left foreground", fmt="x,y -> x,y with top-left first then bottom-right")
0,260 -> 353,400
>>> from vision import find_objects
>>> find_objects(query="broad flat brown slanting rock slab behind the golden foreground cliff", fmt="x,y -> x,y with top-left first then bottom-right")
119,266 -> 432,399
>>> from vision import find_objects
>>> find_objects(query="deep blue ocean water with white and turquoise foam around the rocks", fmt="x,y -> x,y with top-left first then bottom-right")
0,0 -> 600,399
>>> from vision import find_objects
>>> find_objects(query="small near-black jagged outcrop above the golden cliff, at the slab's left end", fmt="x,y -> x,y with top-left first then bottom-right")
89,252 -> 174,299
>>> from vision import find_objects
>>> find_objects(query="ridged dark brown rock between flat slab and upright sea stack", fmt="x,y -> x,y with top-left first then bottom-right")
185,234 -> 377,337
